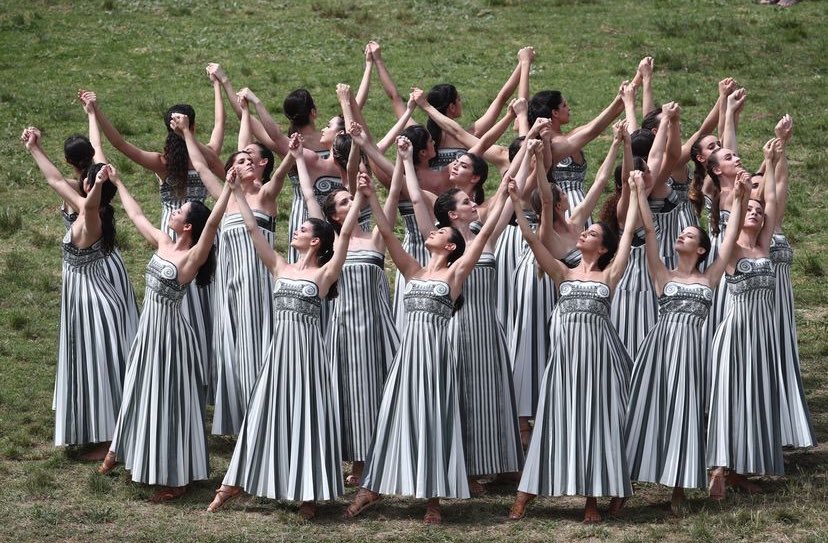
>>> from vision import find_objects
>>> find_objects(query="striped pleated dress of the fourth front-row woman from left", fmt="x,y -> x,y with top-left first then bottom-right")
518,281 -> 632,496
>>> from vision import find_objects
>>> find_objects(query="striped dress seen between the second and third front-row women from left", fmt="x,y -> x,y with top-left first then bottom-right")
329,250 -> 400,461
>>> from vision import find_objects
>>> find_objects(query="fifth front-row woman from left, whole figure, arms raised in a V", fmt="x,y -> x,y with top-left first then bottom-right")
626,172 -> 750,513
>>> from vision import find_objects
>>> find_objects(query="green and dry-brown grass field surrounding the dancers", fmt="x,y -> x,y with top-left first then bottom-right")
0,0 -> 828,542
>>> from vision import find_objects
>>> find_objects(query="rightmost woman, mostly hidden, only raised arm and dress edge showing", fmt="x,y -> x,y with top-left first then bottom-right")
770,115 -> 817,448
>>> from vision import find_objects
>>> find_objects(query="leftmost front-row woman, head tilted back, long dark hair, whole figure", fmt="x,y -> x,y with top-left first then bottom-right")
98,170 -> 235,503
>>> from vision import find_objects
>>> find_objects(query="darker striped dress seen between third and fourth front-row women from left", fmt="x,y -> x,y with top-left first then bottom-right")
449,253 -> 523,476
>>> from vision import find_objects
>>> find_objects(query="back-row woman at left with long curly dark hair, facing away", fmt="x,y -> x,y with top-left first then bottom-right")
83,88 -> 224,400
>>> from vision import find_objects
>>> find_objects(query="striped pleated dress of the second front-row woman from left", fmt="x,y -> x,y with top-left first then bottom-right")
223,278 -> 343,501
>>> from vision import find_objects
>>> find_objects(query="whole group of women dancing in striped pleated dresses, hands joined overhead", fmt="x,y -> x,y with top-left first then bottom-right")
21,42 -> 816,524
